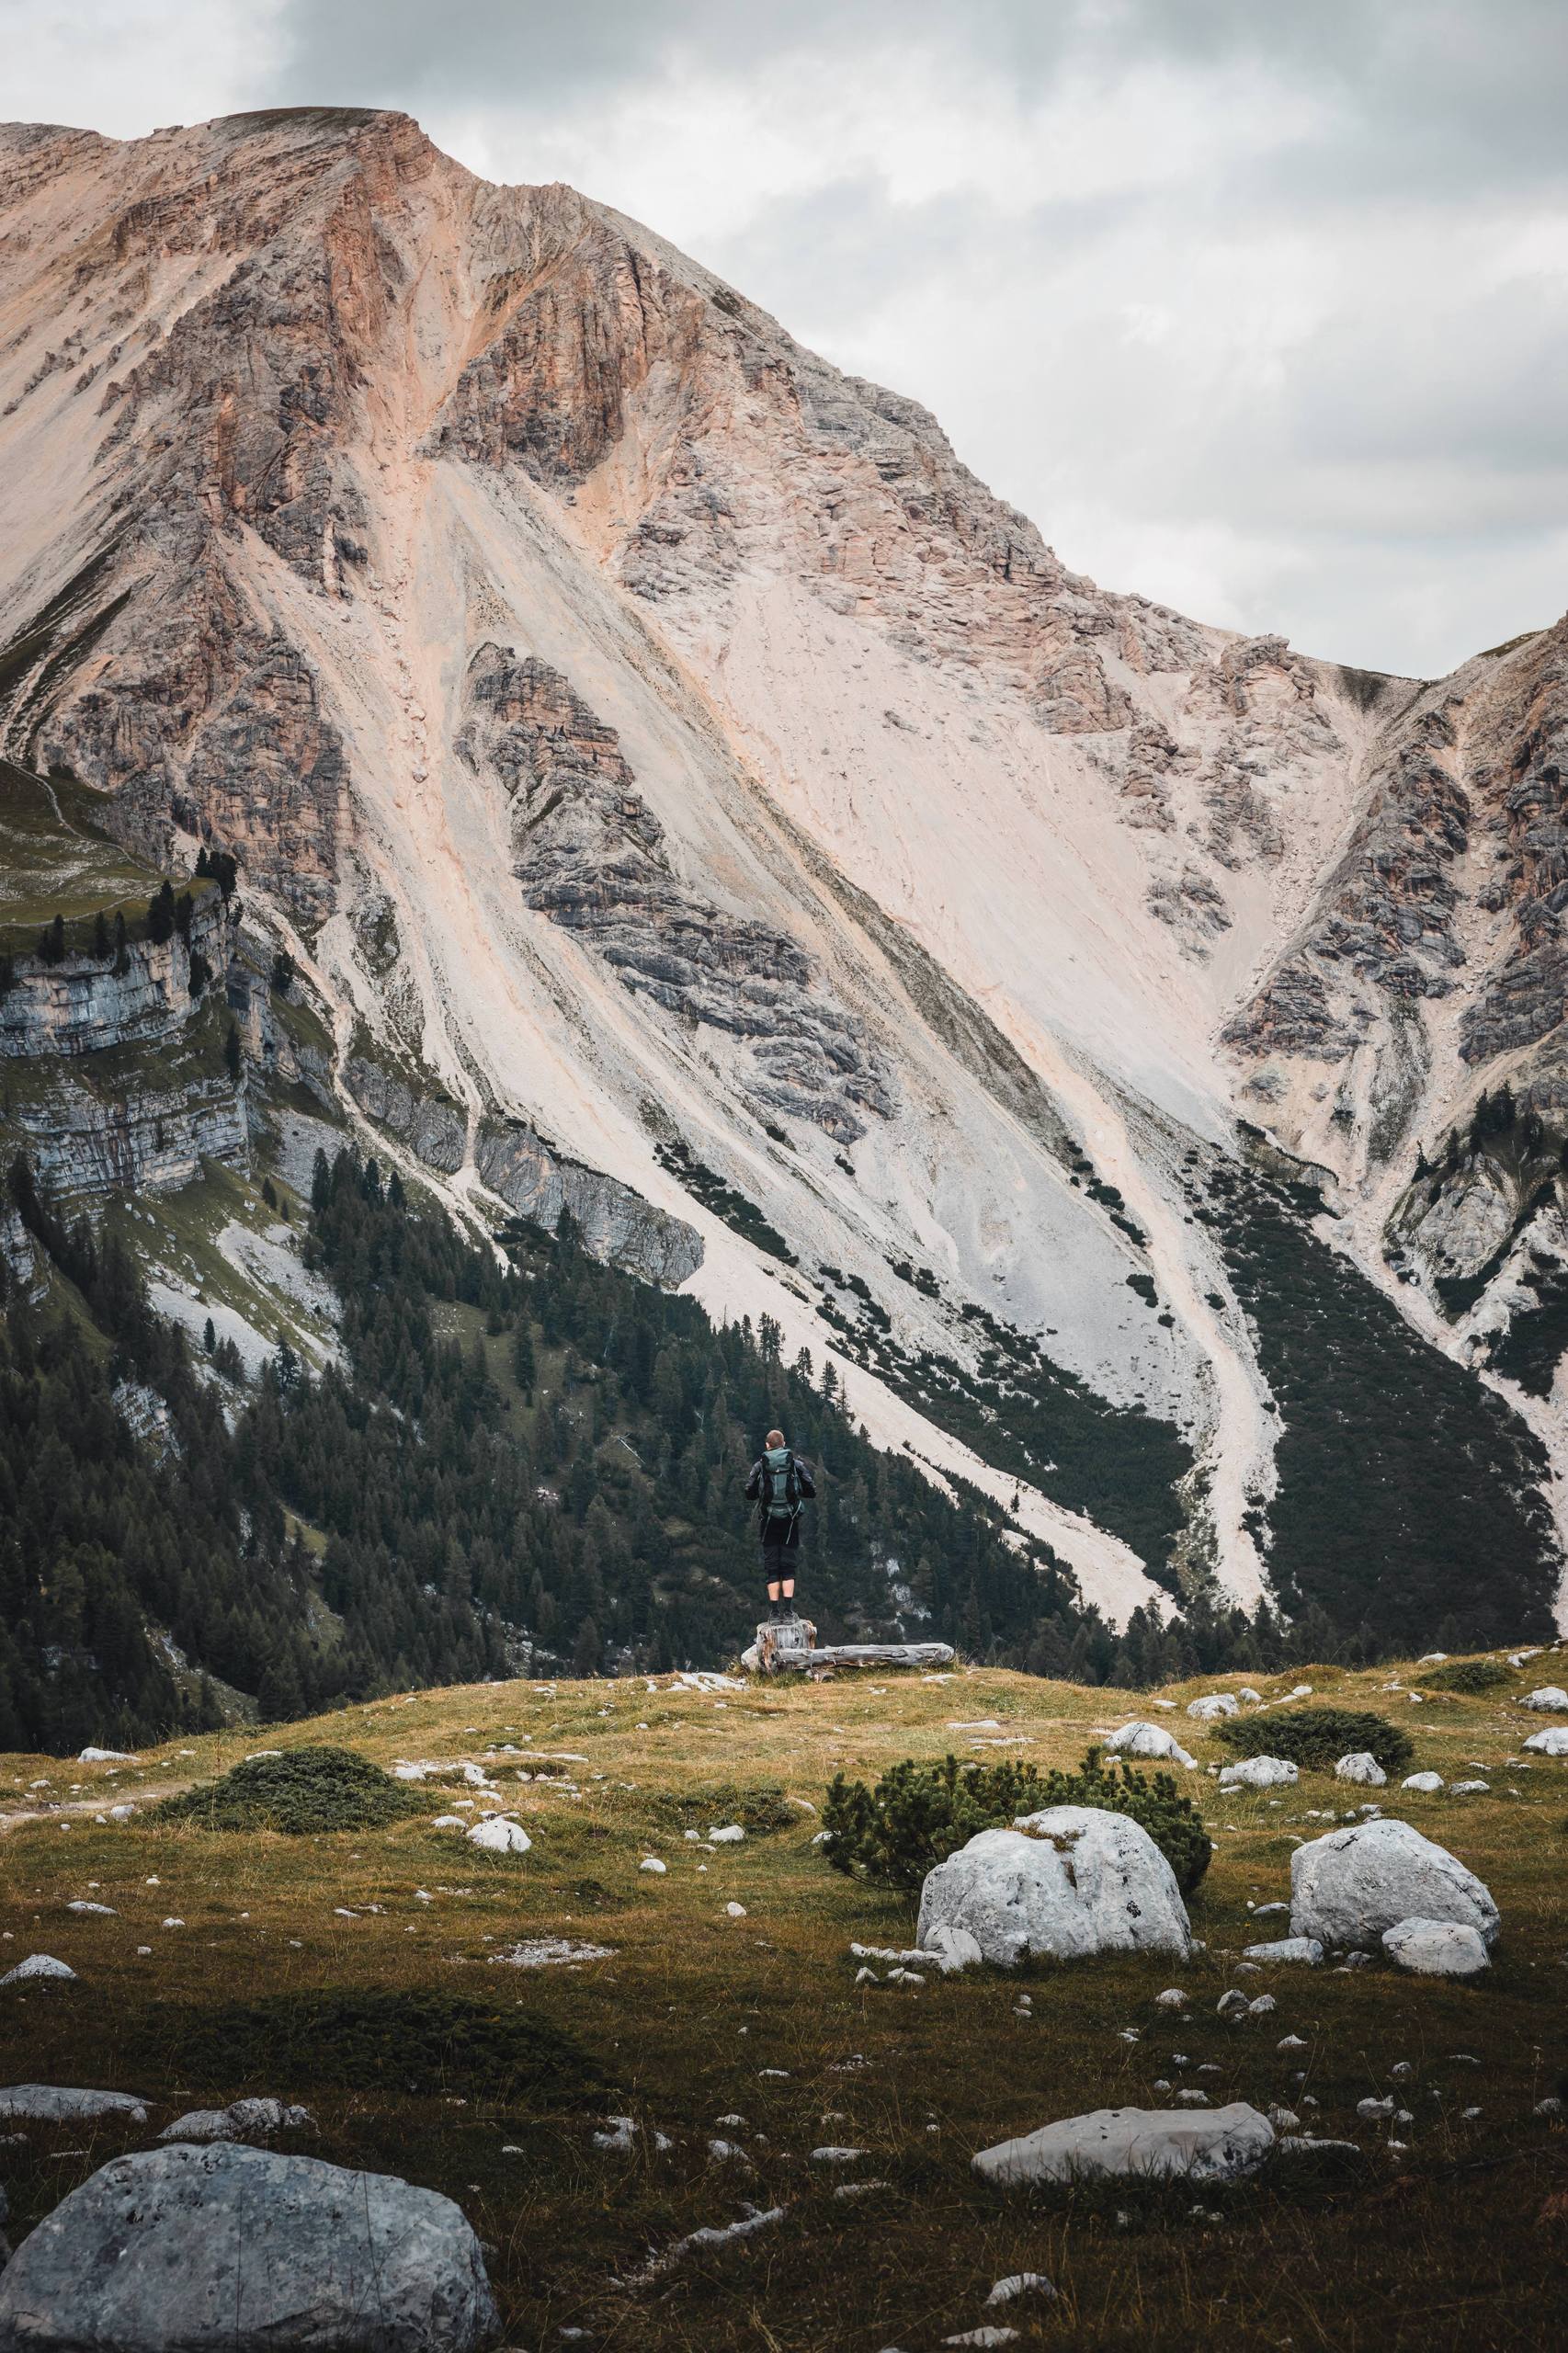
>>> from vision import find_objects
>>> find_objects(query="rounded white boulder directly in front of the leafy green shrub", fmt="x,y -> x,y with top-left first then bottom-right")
915,1805 -> 1191,1970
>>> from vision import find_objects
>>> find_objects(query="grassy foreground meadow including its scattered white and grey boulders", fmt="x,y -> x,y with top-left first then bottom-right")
0,1650 -> 1568,2353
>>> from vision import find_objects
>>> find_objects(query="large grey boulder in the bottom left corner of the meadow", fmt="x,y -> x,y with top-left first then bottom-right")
0,2142 -> 499,2353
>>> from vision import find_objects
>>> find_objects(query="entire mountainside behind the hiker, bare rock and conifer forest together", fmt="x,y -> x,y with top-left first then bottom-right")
0,110 -> 1568,1748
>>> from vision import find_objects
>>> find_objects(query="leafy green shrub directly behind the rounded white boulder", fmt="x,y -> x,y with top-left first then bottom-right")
822,1748 -> 1215,1894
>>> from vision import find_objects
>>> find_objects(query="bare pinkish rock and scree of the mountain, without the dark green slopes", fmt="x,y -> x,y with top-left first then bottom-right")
0,110 -> 1568,1612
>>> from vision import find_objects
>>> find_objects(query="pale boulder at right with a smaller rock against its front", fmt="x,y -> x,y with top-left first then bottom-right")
1290,1819 -> 1500,1946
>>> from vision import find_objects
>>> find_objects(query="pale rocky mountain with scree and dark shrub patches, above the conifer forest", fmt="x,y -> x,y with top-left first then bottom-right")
0,108 -> 1568,1644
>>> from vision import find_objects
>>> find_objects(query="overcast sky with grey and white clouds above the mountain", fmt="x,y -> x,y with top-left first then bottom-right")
0,0 -> 1568,676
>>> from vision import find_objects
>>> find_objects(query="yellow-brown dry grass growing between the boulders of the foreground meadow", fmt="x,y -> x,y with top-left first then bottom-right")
0,1659 -> 1568,2353
